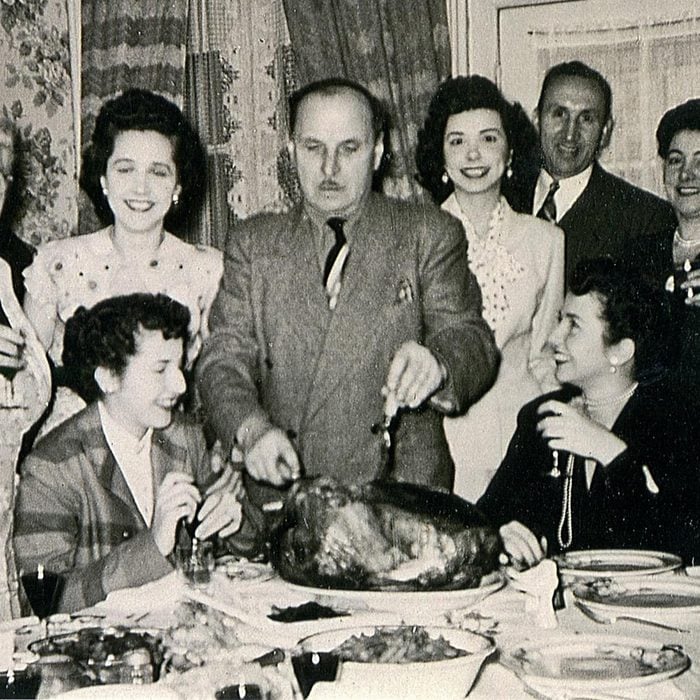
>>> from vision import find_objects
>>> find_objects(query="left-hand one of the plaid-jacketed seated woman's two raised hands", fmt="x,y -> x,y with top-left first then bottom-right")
151,472 -> 201,557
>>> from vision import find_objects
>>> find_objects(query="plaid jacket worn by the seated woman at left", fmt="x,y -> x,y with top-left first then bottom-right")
14,404 -> 210,612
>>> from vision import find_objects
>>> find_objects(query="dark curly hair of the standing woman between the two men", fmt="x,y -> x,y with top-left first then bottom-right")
416,75 -> 539,204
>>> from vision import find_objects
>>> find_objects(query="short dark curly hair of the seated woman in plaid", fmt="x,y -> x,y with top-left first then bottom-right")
63,294 -> 190,403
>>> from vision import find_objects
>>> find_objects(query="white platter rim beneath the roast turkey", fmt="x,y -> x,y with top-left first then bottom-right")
287,572 -> 506,616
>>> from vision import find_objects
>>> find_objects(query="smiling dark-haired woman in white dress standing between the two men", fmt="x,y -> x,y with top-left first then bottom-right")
416,76 -> 564,501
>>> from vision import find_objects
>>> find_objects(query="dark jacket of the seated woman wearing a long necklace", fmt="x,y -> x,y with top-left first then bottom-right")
478,383 -> 700,561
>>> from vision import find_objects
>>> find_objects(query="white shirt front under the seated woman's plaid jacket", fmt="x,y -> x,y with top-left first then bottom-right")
97,401 -> 153,525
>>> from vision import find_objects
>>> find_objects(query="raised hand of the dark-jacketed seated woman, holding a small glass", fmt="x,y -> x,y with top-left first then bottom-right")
537,401 -> 627,465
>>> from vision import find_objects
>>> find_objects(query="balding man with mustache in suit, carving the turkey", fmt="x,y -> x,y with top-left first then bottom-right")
197,79 -> 498,532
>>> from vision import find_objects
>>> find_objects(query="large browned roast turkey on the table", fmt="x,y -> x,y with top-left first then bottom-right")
270,478 -> 501,591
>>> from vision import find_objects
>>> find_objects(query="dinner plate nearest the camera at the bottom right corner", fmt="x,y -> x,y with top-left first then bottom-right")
501,635 -> 690,695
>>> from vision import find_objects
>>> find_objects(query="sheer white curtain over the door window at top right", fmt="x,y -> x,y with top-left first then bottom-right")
532,12 -> 700,196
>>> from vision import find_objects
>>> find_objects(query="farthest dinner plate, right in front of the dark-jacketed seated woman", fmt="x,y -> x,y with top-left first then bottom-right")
554,549 -> 683,582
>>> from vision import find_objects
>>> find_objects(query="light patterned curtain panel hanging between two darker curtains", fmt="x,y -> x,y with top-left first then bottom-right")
185,0 -> 294,248
